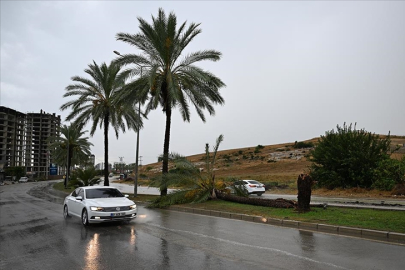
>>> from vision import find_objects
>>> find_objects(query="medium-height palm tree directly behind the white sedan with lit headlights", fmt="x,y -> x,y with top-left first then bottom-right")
61,61 -> 142,186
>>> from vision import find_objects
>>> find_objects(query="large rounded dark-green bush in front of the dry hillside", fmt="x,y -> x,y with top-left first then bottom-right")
310,124 -> 390,189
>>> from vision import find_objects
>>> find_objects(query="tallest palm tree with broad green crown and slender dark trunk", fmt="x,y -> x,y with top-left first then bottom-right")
115,9 -> 225,196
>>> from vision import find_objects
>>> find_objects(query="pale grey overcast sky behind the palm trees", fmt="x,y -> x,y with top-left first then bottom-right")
0,1 -> 405,165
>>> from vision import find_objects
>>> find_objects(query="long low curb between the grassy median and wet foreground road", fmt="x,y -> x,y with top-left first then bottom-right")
168,205 -> 405,245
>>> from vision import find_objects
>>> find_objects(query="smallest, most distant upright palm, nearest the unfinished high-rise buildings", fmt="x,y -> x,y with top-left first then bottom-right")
48,125 -> 93,187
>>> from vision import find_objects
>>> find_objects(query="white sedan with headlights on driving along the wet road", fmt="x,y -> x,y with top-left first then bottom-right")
63,186 -> 137,226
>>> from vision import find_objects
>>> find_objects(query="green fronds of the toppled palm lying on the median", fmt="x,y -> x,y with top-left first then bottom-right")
150,135 -> 224,207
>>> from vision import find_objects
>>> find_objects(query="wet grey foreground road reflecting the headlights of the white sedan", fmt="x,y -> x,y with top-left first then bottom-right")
0,183 -> 405,270
